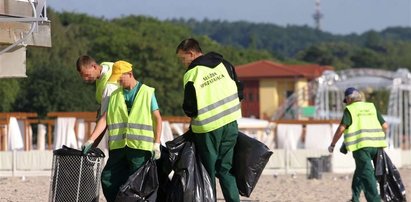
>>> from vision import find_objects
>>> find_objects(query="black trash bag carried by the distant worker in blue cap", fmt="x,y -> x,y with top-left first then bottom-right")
374,149 -> 407,202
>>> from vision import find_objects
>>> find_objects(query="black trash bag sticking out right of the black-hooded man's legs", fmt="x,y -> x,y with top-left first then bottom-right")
235,132 -> 273,197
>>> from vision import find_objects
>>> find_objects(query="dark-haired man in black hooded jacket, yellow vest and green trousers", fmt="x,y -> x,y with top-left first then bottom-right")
176,38 -> 242,202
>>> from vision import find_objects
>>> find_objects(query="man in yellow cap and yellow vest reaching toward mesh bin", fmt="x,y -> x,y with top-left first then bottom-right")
83,61 -> 162,202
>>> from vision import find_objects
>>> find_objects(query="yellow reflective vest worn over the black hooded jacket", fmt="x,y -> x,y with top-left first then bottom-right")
184,63 -> 241,133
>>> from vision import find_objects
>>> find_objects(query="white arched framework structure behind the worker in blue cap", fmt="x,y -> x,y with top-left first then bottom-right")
273,68 -> 411,149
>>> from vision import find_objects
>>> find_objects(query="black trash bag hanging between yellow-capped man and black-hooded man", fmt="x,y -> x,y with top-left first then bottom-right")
166,132 -> 215,202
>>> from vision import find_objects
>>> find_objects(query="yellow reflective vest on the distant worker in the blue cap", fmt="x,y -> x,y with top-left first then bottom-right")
344,102 -> 387,151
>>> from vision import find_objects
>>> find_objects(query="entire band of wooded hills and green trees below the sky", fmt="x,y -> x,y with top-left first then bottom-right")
0,9 -> 411,117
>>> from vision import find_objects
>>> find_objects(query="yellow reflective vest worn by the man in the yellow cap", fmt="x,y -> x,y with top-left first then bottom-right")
107,84 -> 154,151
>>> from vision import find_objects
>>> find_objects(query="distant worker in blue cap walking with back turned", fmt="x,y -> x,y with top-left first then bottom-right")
328,87 -> 388,202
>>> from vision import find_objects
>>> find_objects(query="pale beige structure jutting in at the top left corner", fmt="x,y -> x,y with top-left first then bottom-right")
0,0 -> 51,78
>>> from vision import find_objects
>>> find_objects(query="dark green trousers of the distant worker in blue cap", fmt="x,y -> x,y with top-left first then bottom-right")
351,147 -> 381,202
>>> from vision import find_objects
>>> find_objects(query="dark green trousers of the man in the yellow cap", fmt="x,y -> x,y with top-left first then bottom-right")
101,147 -> 151,202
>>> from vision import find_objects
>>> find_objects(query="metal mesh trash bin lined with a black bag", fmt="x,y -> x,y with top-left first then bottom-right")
49,146 -> 104,202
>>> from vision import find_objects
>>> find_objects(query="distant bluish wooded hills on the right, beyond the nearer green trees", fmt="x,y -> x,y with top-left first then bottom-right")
170,19 -> 411,70
